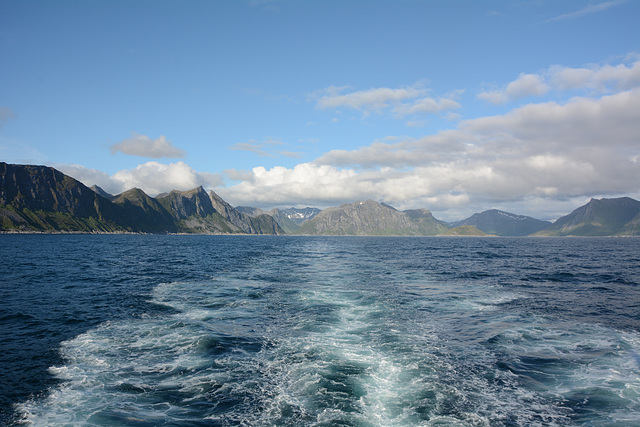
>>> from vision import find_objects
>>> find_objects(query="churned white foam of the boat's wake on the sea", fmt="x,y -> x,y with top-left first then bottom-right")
21,280 -> 640,426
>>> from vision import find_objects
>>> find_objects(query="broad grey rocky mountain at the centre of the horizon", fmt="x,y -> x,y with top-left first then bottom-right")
296,200 -> 446,236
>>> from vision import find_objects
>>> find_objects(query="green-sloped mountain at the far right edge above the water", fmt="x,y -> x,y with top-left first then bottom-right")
536,197 -> 640,236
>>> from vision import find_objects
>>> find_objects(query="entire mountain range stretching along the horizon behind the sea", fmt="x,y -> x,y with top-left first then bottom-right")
0,162 -> 640,236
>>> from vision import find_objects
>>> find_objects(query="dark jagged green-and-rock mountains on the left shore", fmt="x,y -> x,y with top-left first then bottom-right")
0,163 -> 284,234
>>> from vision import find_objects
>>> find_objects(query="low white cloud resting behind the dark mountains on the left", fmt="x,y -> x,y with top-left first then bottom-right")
56,161 -> 223,196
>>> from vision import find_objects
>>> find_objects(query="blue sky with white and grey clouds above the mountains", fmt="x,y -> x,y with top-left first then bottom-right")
0,0 -> 640,221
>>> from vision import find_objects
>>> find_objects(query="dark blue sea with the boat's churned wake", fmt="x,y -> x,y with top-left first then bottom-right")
0,234 -> 640,426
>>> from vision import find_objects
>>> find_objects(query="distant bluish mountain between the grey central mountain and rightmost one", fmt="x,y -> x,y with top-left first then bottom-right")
450,209 -> 551,236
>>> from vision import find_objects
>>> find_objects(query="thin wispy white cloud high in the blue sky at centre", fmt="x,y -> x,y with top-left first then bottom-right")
316,84 -> 460,117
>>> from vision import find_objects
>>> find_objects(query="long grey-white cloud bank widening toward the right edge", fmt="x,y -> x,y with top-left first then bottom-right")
220,88 -> 640,221
